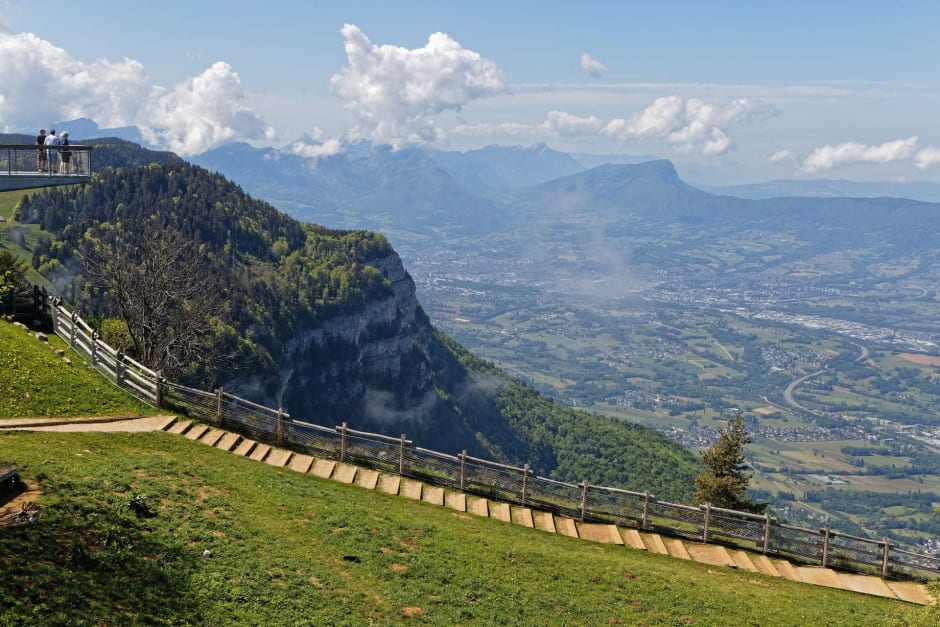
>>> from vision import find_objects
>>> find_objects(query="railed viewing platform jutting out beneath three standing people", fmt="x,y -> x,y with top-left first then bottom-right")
0,144 -> 92,192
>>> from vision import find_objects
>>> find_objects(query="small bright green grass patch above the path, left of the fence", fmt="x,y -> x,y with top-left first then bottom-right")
0,322 -> 156,419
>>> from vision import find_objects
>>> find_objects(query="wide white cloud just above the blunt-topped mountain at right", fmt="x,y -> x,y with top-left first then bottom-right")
602,96 -> 776,155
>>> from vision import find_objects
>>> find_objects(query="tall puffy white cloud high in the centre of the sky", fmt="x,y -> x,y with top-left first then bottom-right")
330,24 -> 506,146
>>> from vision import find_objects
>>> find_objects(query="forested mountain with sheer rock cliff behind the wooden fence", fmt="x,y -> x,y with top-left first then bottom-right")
5,157 -> 698,500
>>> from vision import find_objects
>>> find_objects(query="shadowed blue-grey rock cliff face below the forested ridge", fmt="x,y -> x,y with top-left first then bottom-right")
233,253 -> 440,436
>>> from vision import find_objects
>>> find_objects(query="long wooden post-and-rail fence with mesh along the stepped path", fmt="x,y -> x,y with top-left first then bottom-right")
40,302 -> 940,580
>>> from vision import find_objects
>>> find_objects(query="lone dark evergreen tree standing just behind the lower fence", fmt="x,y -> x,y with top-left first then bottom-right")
695,414 -> 767,514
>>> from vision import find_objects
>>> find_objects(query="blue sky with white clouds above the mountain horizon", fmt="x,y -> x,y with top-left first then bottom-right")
0,0 -> 940,184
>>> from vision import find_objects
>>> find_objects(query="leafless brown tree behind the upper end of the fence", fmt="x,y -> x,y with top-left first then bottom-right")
84,227 -> 221,378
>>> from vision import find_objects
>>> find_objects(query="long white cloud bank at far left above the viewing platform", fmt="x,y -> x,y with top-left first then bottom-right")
0,29 -> 272,155
